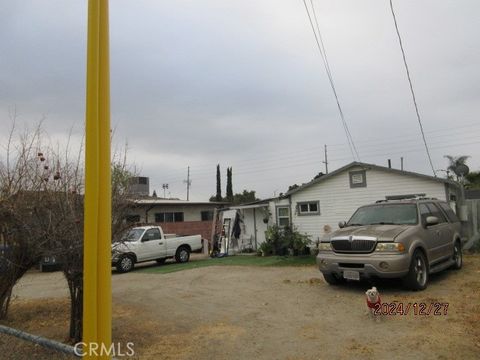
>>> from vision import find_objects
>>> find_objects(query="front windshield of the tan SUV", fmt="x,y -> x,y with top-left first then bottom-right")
347,204 -> 418,226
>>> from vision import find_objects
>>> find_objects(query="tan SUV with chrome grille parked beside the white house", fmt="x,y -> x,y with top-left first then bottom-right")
317,198 -> 462,290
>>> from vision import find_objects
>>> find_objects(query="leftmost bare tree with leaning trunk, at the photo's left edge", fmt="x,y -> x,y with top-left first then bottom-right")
0,124 -> 46,319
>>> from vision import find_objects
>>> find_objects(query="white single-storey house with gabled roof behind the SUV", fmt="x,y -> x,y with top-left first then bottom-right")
225,162 -> 459,246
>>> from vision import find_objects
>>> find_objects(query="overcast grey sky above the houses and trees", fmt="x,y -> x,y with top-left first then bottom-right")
0,0 -> 480,200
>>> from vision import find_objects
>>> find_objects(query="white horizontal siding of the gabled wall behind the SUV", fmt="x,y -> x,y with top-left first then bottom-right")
291,167 -> 446,241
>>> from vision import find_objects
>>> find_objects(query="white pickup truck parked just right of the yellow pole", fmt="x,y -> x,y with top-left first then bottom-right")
112,226 -> 202,273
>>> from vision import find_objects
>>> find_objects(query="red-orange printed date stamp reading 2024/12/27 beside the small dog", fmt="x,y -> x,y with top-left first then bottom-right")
373,302 -> 449,316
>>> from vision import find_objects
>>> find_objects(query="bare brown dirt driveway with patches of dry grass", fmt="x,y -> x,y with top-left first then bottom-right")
0,256 -> 480,360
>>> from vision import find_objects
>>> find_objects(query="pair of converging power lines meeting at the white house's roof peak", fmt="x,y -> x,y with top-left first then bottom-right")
303,0 -> 360,161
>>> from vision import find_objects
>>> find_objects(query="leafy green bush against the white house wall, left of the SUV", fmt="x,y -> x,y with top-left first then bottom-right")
260,225 -> 310,256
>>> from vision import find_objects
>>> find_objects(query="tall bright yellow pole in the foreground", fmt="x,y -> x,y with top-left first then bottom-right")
83,0 -> 111,359
